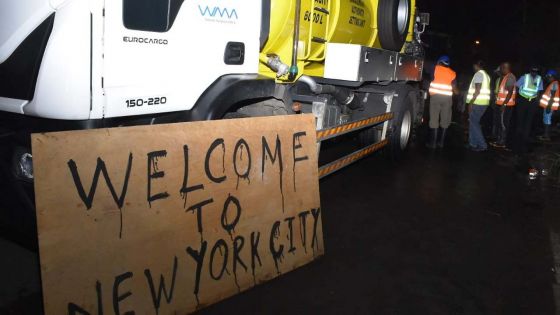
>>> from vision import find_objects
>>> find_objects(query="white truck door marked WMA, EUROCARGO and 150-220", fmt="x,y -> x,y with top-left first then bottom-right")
103,0 -> 260,117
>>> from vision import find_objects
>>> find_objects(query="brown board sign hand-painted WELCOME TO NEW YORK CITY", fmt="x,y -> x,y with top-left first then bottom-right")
32,115 -> 323,315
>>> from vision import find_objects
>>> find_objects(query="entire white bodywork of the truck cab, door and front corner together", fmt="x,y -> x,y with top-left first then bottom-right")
0,0 -> 261,120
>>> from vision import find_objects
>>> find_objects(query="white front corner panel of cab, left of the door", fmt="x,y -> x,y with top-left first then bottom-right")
23,0 -> 91,120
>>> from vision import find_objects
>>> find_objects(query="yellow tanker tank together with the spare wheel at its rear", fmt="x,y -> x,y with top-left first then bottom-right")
259,0 -> 415,82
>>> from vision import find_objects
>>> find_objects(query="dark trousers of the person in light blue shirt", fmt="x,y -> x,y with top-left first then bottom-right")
513,96 -> 539,155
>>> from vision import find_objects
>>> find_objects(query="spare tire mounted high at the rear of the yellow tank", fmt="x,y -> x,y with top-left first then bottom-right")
377,0 -> 412,51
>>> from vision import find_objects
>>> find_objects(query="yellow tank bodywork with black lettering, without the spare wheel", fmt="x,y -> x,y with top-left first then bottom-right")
259,0 -> 416,82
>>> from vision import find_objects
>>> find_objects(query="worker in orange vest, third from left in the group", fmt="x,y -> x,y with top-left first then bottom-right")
490,62 -> 517,148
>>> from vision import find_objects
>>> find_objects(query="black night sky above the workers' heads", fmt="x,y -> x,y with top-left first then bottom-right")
417,0 -> 560,71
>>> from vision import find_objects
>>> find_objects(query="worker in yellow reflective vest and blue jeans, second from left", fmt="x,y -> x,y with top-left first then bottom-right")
467,61 -> 491,152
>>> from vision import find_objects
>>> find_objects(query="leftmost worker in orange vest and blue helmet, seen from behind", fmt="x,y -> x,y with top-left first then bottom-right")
426,56 -> 457,149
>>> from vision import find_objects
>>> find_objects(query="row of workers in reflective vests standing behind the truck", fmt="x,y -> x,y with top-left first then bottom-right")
426,56 -> 560,159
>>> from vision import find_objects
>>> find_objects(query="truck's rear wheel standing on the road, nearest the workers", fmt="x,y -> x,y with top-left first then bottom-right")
389,95 -> 414,161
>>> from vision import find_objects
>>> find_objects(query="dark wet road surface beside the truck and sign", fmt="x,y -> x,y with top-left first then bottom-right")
0,126 -> 560,315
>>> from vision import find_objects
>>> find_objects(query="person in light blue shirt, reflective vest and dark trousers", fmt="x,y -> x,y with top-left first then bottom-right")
513,67 -> 543,156
